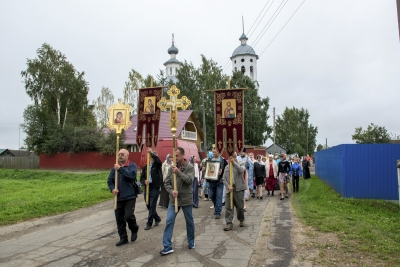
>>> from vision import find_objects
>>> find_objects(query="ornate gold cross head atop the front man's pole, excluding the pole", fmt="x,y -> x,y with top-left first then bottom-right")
157,85 -> 192,133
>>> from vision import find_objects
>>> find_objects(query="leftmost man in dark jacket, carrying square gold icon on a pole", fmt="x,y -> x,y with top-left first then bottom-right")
107,149 -> 139,246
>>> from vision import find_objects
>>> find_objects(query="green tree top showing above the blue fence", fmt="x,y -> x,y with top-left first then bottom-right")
351,123 -> 399,144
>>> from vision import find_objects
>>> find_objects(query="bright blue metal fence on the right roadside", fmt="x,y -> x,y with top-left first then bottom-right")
315,144 -> 400,200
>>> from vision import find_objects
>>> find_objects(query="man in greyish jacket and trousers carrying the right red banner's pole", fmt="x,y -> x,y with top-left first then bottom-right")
222,153 -> 247,231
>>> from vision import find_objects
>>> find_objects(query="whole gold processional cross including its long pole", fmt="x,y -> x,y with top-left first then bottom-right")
157,85 -> 192,213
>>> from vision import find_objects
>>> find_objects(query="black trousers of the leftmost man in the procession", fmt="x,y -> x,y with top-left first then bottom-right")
114,198 -> 139,239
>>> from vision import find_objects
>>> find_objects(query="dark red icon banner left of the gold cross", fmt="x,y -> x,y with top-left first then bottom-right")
136,87 -> 162,147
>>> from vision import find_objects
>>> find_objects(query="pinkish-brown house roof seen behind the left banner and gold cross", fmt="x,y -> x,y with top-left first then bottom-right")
125,110 -> 200,145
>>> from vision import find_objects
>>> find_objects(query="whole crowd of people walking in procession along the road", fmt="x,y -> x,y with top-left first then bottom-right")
107,149 -> 311,255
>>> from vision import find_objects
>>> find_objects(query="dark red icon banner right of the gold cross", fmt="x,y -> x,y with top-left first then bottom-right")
214,89 -> 244,156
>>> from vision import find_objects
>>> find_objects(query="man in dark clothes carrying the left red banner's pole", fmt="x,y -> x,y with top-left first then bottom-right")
140,147 -> 163,230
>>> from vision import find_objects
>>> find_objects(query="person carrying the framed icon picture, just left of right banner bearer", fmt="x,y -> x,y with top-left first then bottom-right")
208,145 -> 228,219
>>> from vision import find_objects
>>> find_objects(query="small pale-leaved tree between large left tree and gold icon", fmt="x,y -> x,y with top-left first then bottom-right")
93,86 -> 114,128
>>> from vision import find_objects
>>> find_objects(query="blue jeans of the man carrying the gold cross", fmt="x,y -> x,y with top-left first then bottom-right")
163,204 -> 194,249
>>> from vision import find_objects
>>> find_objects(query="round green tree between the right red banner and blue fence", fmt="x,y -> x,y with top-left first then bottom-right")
275,107 -> 318,156
